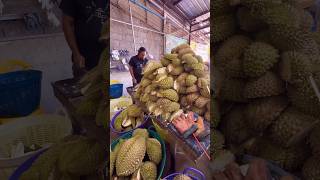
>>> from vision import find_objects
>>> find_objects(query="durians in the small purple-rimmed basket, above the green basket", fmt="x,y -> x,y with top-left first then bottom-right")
114,104 -> 144,132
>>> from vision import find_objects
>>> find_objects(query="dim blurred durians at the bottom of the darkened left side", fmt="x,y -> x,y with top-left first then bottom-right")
20,135 -> 107,180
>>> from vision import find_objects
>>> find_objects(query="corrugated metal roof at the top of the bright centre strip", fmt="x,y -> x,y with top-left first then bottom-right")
173,0 -> 210,20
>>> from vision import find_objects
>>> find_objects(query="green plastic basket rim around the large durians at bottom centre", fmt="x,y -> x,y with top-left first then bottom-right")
111,129 -> 167,180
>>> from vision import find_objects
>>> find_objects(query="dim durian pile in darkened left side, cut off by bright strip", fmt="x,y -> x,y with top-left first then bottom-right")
76,20 -> 109,128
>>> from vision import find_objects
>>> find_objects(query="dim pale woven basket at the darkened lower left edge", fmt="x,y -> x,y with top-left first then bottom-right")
0,115 -> 72,179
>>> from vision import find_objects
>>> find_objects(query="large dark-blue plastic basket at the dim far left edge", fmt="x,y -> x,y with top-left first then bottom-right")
0,70 -> 42,117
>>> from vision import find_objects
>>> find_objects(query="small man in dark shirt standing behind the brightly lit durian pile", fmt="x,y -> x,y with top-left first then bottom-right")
129,47 -> 148,86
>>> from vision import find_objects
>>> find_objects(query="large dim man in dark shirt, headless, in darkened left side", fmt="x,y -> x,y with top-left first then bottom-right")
60,0 -> 109,77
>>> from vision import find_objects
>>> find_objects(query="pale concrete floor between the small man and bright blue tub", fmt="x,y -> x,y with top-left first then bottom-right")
110,71 -> 132,96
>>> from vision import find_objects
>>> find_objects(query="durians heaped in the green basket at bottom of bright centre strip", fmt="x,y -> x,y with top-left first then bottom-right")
110,129 -> 162,180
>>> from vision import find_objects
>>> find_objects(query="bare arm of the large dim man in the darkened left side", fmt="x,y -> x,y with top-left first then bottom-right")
62,15 -> 85,67
